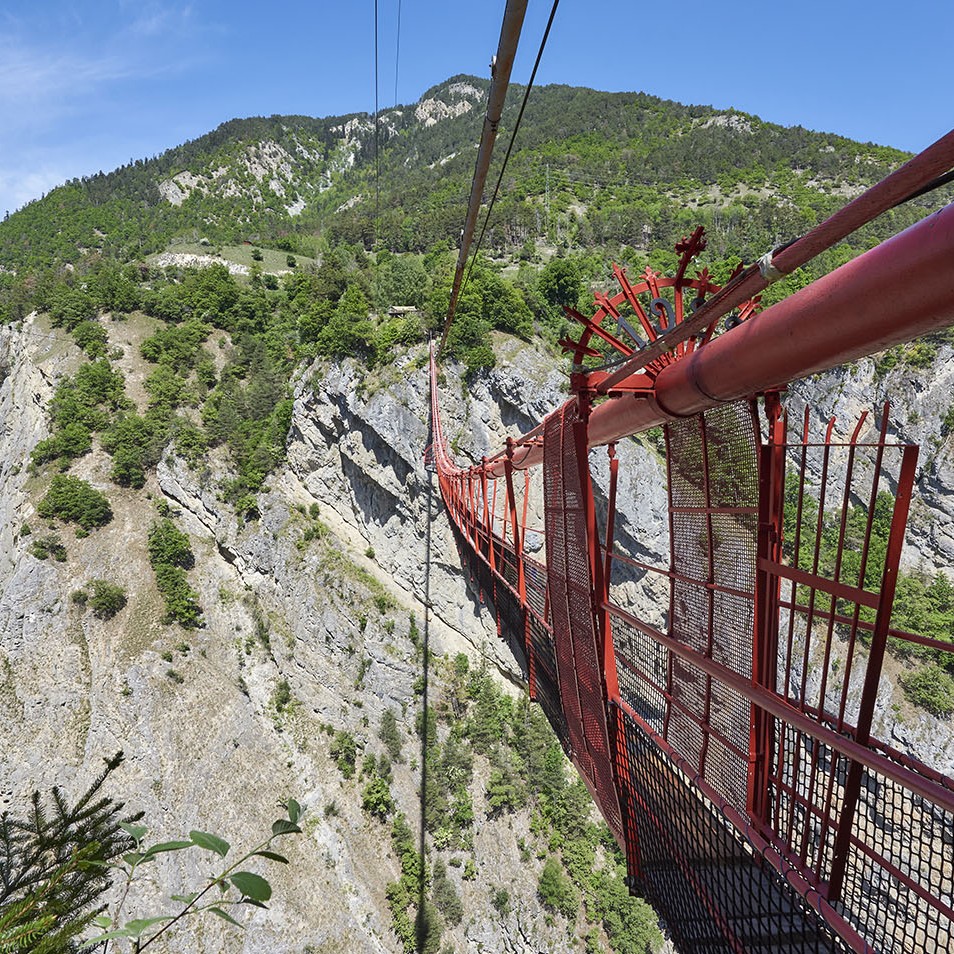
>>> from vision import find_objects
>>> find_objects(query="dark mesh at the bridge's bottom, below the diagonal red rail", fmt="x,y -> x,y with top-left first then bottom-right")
611,707 -> 849,954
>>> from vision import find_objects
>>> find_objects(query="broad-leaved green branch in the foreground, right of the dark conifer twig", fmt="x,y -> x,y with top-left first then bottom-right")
83,798 -> 302,954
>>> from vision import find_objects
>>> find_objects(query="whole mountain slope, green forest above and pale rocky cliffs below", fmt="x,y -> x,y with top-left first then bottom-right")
0,70 -> 954,954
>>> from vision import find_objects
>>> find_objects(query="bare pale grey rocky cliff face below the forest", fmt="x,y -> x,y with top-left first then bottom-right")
0,318 -> 954,954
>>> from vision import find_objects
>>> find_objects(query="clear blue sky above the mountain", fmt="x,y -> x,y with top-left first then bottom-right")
0,0 -> 954,215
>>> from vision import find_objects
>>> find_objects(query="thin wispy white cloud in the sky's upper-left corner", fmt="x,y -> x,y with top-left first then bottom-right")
0,0 -> 207,215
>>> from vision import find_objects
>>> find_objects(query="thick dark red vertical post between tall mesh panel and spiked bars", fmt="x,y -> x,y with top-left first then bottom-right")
747,391 -> 786,825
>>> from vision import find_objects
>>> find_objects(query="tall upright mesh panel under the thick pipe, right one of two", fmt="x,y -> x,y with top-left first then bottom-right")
660,403 -> 758,810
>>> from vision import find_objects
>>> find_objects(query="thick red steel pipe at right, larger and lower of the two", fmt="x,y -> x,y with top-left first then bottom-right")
588,198 -> 954,450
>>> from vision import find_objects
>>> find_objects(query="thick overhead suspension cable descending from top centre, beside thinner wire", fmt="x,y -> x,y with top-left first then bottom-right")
437,0 -> 527,355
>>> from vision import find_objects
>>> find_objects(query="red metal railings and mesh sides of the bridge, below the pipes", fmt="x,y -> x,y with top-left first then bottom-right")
432,340 -> 954,954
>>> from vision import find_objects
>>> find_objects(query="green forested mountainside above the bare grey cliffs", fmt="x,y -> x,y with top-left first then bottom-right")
7,76 -> 952,368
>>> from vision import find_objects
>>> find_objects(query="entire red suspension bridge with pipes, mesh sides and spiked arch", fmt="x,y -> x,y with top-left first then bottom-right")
429,133 -> 954,954
